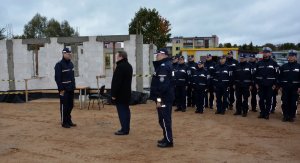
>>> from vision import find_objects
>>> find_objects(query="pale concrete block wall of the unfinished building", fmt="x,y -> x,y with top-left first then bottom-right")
0,35 -> 153,91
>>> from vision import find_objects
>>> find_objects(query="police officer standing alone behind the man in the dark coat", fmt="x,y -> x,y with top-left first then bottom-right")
150,48 -> 174,148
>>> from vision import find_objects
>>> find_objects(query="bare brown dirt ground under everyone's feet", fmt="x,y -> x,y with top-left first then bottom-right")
0,99 -> 300,163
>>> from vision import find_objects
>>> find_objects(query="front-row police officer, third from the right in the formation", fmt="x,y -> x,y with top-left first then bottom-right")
233,54 -> 252,117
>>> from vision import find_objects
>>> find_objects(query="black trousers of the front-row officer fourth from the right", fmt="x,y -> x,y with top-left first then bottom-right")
215,87 -> 228,113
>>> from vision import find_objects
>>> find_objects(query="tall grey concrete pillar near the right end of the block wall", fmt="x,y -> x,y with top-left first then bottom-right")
135,35 -> 145,92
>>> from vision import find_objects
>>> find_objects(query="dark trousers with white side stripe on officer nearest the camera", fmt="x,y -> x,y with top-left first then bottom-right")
156,103 -> 173,143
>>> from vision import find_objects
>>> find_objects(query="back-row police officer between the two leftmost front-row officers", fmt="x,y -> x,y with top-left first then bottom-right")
187,55 -> 197,107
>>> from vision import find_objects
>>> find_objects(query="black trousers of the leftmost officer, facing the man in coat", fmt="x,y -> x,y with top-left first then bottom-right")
59,91 -> 74,124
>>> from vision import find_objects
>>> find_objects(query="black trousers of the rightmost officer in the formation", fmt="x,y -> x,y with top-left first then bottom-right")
281,87 -> 299,118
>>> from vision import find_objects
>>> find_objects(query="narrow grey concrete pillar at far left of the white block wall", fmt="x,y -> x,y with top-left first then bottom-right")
6,40 -> 16,90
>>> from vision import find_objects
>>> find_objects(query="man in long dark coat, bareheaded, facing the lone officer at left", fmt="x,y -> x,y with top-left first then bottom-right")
111,51 -> 133,135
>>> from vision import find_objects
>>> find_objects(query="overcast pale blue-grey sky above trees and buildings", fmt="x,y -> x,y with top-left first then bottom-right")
0,0 -> 300,45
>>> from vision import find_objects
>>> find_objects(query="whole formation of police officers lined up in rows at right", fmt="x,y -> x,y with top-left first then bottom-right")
172,47 -> 300,122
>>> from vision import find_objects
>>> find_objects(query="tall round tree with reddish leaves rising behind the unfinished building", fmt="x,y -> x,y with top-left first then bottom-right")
129,8 -> 171,48
